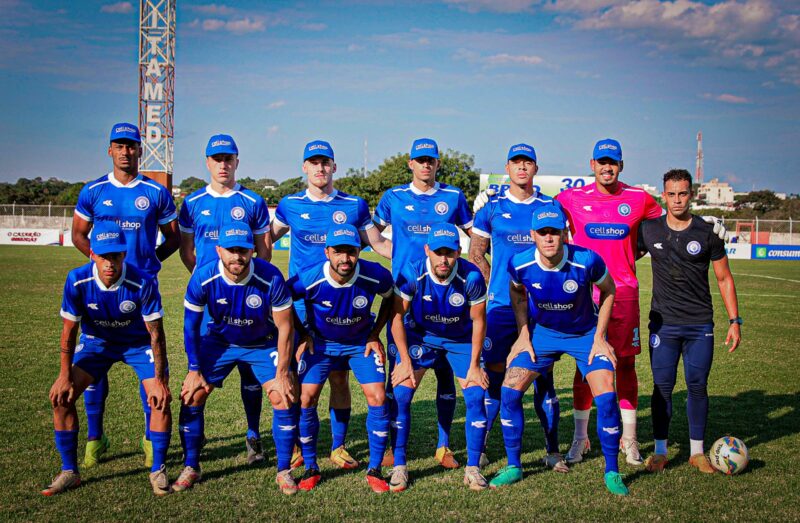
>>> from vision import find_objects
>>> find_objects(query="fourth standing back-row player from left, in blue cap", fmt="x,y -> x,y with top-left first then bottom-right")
374,138 -> 472,468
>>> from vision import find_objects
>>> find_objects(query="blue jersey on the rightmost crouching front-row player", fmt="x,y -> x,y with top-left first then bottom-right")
508,245 -> 608,334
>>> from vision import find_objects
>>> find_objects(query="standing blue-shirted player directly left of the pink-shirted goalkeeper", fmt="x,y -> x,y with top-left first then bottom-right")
469,143 -> 569,472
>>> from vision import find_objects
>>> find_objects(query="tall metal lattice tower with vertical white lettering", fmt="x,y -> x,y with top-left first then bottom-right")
139,0 -> 176,189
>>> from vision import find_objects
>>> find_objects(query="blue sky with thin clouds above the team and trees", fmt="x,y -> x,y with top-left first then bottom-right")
0,0 -> 800,192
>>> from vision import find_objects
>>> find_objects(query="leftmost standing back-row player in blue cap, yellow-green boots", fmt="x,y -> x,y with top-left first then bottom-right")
72,122 -> 180,468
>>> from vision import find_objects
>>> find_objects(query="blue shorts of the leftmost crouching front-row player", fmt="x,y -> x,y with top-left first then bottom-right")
72,336 -> 162,381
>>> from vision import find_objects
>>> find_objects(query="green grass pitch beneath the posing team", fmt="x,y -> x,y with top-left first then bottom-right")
0,246 -> 800,521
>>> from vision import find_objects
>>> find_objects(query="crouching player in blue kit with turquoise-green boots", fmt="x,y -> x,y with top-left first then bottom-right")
491,204 -> 628,496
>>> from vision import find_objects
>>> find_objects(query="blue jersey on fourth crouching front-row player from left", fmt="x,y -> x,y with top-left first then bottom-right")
394,257 -> 486,353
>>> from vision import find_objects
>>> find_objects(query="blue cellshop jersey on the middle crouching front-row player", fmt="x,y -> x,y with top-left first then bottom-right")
289,260 -> 394,356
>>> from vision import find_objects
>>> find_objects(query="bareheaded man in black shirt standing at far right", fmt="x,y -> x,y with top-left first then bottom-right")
639,169 -> 742,473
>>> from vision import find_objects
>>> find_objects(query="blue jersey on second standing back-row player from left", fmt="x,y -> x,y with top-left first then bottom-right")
178,183 -> 270,267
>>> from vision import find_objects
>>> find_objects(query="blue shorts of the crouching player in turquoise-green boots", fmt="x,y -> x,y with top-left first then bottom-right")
509,326 -> 614,377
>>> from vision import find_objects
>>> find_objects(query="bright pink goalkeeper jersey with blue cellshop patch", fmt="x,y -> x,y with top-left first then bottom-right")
556,182 -> 663,301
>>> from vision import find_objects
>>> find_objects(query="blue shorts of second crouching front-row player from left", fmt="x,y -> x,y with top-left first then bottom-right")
198,339 -> 278,387
